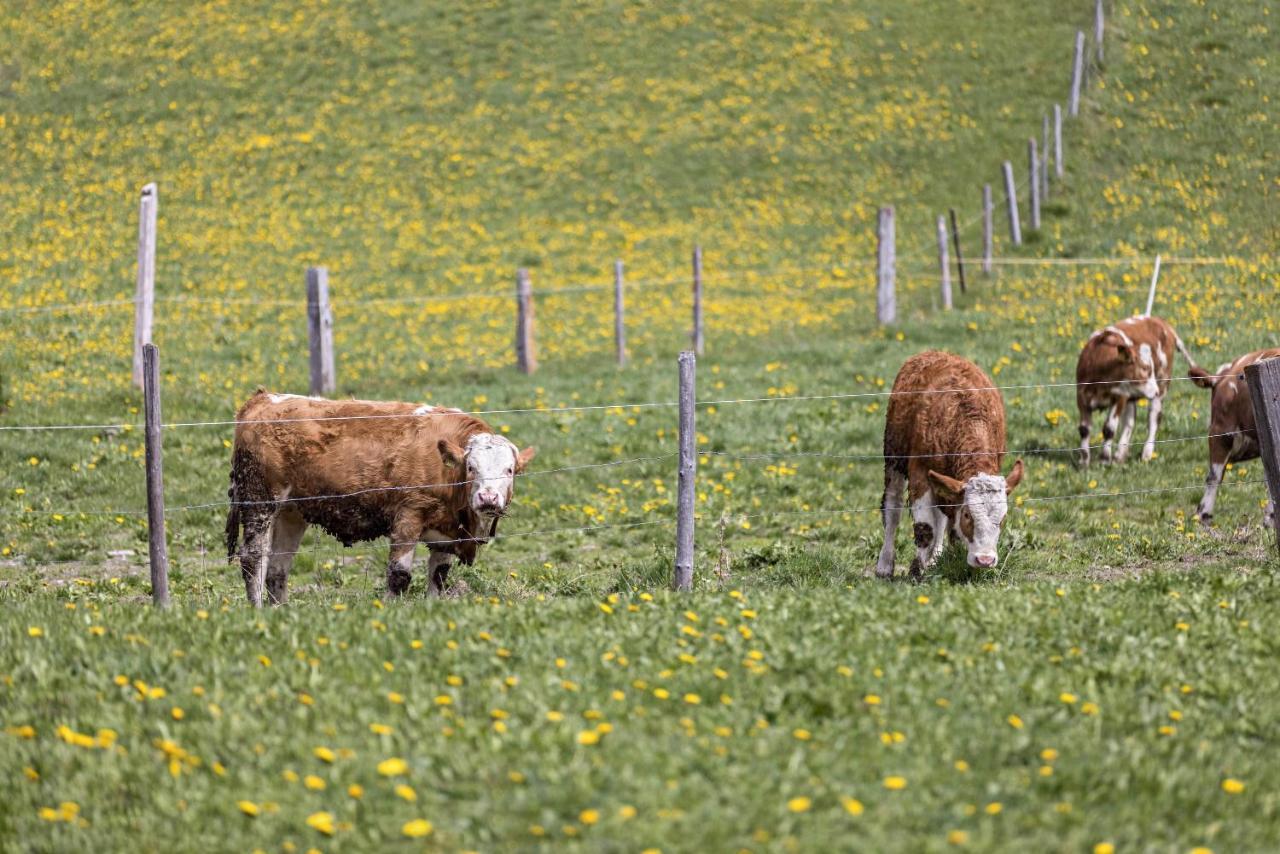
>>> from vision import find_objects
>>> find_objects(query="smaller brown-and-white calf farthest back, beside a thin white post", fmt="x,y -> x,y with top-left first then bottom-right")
1075,315 -> 1197,466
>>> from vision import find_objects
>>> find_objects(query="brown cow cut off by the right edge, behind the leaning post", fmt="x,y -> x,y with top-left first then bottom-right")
1192,347 -> 1280,528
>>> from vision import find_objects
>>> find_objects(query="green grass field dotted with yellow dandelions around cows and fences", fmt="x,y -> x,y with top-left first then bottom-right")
0,1 -> 1280,851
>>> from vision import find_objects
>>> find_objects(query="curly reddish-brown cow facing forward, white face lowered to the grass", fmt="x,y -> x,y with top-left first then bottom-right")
876,350 -> 1023,579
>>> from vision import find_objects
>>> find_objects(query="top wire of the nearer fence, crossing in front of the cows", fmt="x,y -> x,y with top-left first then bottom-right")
0,374 -> 1243,431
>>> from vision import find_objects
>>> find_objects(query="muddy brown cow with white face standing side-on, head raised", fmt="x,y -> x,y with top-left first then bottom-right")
227,389 -> 534,606
